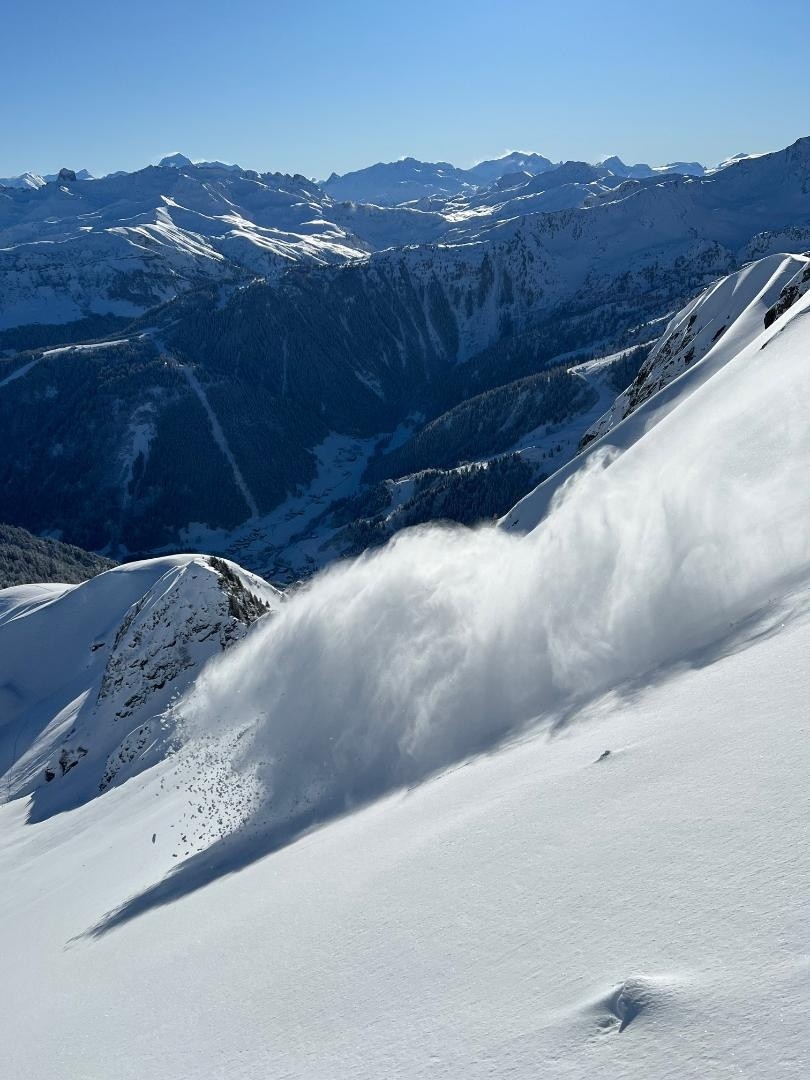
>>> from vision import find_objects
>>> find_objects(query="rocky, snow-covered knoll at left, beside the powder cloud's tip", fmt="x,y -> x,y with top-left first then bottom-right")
0,555 -> 279,815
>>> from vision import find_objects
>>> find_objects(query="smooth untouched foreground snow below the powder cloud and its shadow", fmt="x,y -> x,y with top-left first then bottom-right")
0,596 -> 810,1080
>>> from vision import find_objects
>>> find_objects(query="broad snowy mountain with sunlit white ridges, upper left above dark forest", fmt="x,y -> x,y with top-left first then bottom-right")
0,164 -> 366,328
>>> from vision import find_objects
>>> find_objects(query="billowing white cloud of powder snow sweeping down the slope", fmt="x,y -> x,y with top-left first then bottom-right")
180,265 -> 810,836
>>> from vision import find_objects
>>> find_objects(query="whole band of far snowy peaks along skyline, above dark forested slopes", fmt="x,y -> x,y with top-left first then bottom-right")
0,144 -> 786,332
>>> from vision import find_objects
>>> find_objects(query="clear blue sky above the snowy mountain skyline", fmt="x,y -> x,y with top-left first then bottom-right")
0,0 -> 810,177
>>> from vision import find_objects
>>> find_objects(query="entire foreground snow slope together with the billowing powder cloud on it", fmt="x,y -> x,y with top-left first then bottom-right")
0,225 -> 810,1080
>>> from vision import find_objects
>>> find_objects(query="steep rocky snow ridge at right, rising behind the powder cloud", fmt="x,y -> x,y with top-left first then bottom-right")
581,255 -> 810,446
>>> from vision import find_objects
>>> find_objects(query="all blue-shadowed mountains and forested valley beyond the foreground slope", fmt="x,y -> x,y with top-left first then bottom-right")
0,139 -> 810,580
